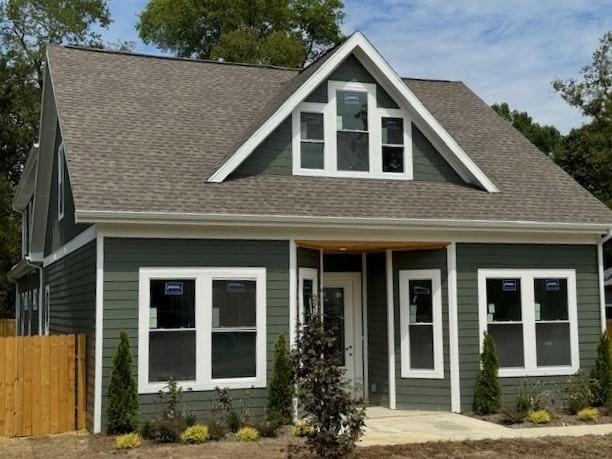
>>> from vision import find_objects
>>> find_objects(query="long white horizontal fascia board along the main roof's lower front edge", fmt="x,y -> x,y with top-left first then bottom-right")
75,210 -> 612,235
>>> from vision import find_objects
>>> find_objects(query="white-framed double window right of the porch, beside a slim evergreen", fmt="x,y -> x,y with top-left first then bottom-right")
478,269 -> 580,377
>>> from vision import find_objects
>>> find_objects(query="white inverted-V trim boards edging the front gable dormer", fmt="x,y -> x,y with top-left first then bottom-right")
208,32 -> 499,193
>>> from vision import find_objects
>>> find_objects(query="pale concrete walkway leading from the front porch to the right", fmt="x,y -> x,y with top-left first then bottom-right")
359,407 -> 612,446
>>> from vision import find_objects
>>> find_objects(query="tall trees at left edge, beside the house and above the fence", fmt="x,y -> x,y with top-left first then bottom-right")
0,0 -> 110,317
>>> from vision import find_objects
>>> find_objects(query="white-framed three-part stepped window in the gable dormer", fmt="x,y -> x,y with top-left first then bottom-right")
292,81 -> 412,180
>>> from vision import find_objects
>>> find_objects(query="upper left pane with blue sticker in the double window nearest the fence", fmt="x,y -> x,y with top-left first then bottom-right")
149,279 -> 195,329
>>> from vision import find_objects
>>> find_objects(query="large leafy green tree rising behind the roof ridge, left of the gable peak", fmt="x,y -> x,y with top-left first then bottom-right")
136,0 -> 344,67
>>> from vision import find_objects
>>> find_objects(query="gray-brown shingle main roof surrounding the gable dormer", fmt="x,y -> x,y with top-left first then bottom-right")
49,46 -> 612,226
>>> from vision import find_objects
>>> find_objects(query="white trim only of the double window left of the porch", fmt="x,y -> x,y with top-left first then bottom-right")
138,268 -> 267,394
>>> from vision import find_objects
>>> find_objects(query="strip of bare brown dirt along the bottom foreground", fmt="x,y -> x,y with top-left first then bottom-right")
0,434 -> 612,459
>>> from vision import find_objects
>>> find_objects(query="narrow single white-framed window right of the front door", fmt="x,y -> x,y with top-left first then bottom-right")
399,269 -> 444,379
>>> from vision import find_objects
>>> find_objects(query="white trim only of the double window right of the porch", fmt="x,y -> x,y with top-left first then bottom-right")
478,269 -> 580,378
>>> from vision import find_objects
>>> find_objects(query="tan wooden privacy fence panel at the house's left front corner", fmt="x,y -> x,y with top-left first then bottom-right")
0,334 -> 86,437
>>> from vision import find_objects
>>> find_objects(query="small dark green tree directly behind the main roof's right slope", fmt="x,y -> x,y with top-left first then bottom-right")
491,102 -> 562,155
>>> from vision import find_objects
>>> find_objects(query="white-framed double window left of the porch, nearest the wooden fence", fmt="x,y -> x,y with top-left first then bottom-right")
138,268 -> 266,393
